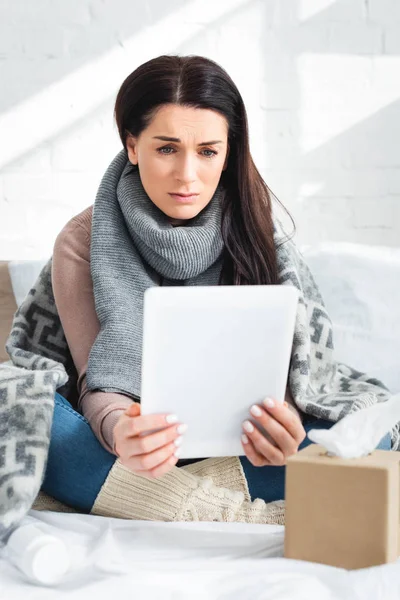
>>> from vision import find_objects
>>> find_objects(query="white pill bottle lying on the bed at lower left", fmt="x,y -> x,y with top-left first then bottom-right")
5,515 -> 71,586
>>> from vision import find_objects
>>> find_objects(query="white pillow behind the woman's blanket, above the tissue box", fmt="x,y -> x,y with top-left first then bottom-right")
301,242 -> 400,392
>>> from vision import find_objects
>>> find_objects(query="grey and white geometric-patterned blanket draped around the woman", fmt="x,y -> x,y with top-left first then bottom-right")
0,227 -> 400,539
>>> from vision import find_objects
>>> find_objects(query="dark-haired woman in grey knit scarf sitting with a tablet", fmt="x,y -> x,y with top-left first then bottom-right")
42,56 -> 390,511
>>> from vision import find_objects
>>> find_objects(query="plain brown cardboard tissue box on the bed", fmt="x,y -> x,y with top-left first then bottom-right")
284,444 -> 400,569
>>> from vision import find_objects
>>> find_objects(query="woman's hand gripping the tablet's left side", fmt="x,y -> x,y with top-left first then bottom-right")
113,402 -> 187,479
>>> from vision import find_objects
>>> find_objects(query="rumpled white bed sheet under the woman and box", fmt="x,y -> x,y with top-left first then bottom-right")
0,511 -> 400,600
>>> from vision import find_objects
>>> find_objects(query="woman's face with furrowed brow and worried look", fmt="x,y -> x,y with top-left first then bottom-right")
127,104 -> 228,225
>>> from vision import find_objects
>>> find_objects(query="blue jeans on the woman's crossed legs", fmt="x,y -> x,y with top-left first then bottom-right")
42,393 -> 391,513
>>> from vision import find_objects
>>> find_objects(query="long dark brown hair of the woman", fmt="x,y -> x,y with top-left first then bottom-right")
115,55 -> 293,285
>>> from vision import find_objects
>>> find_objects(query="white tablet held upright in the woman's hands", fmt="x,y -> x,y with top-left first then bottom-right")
141,285 -> 298,458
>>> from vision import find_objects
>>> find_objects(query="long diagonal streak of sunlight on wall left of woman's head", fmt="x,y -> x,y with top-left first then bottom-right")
0,0 -> 248,168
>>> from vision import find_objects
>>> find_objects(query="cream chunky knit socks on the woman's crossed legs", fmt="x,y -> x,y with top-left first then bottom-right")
33,457 -> 285,525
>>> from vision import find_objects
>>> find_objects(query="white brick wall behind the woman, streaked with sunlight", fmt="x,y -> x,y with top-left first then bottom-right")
0,0 -> 400,260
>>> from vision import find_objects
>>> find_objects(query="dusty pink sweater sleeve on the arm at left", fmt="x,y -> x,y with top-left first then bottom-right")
52,207 -> 132,454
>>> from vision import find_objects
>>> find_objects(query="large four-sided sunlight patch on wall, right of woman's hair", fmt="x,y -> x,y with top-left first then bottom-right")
297,53 -> 400,153
